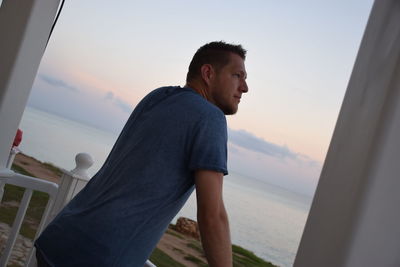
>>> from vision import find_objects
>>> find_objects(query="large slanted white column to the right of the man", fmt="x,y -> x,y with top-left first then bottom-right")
294,0 -> 400,267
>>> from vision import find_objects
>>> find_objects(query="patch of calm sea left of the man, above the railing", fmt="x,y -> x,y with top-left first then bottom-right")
19,107 -> 118,176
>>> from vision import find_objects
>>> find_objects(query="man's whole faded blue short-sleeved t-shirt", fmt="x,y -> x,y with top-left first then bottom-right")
35,87 -> 227,267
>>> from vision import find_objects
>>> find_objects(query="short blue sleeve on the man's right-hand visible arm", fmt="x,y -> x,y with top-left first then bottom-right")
189,113 -> 228,175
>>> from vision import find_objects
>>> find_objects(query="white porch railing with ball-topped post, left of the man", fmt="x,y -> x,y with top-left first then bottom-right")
0,152 -> 156,267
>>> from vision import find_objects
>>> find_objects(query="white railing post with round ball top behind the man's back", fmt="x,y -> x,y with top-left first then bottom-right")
49,153 -> 93,220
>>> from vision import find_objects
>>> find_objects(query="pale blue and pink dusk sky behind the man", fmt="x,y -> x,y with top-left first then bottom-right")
28,0 -> 373,195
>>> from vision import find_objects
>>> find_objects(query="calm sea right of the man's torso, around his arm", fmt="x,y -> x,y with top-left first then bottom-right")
175,175 -> 311,266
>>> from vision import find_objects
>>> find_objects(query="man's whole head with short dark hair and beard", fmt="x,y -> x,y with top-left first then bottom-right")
186,42 -> 248,115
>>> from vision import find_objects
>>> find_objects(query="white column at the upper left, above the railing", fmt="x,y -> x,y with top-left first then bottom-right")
0,0 -> 60,169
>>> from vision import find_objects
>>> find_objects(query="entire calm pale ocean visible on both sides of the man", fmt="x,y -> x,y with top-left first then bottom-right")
19,107 -> 311,267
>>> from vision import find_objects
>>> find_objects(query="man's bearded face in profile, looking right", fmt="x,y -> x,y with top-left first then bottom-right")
210,53 -> 248,115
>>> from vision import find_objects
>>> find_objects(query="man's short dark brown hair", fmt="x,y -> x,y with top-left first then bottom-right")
186,41 -> 246,82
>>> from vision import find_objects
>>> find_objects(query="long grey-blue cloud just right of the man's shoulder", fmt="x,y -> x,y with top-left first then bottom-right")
228,129 -> 299,159
